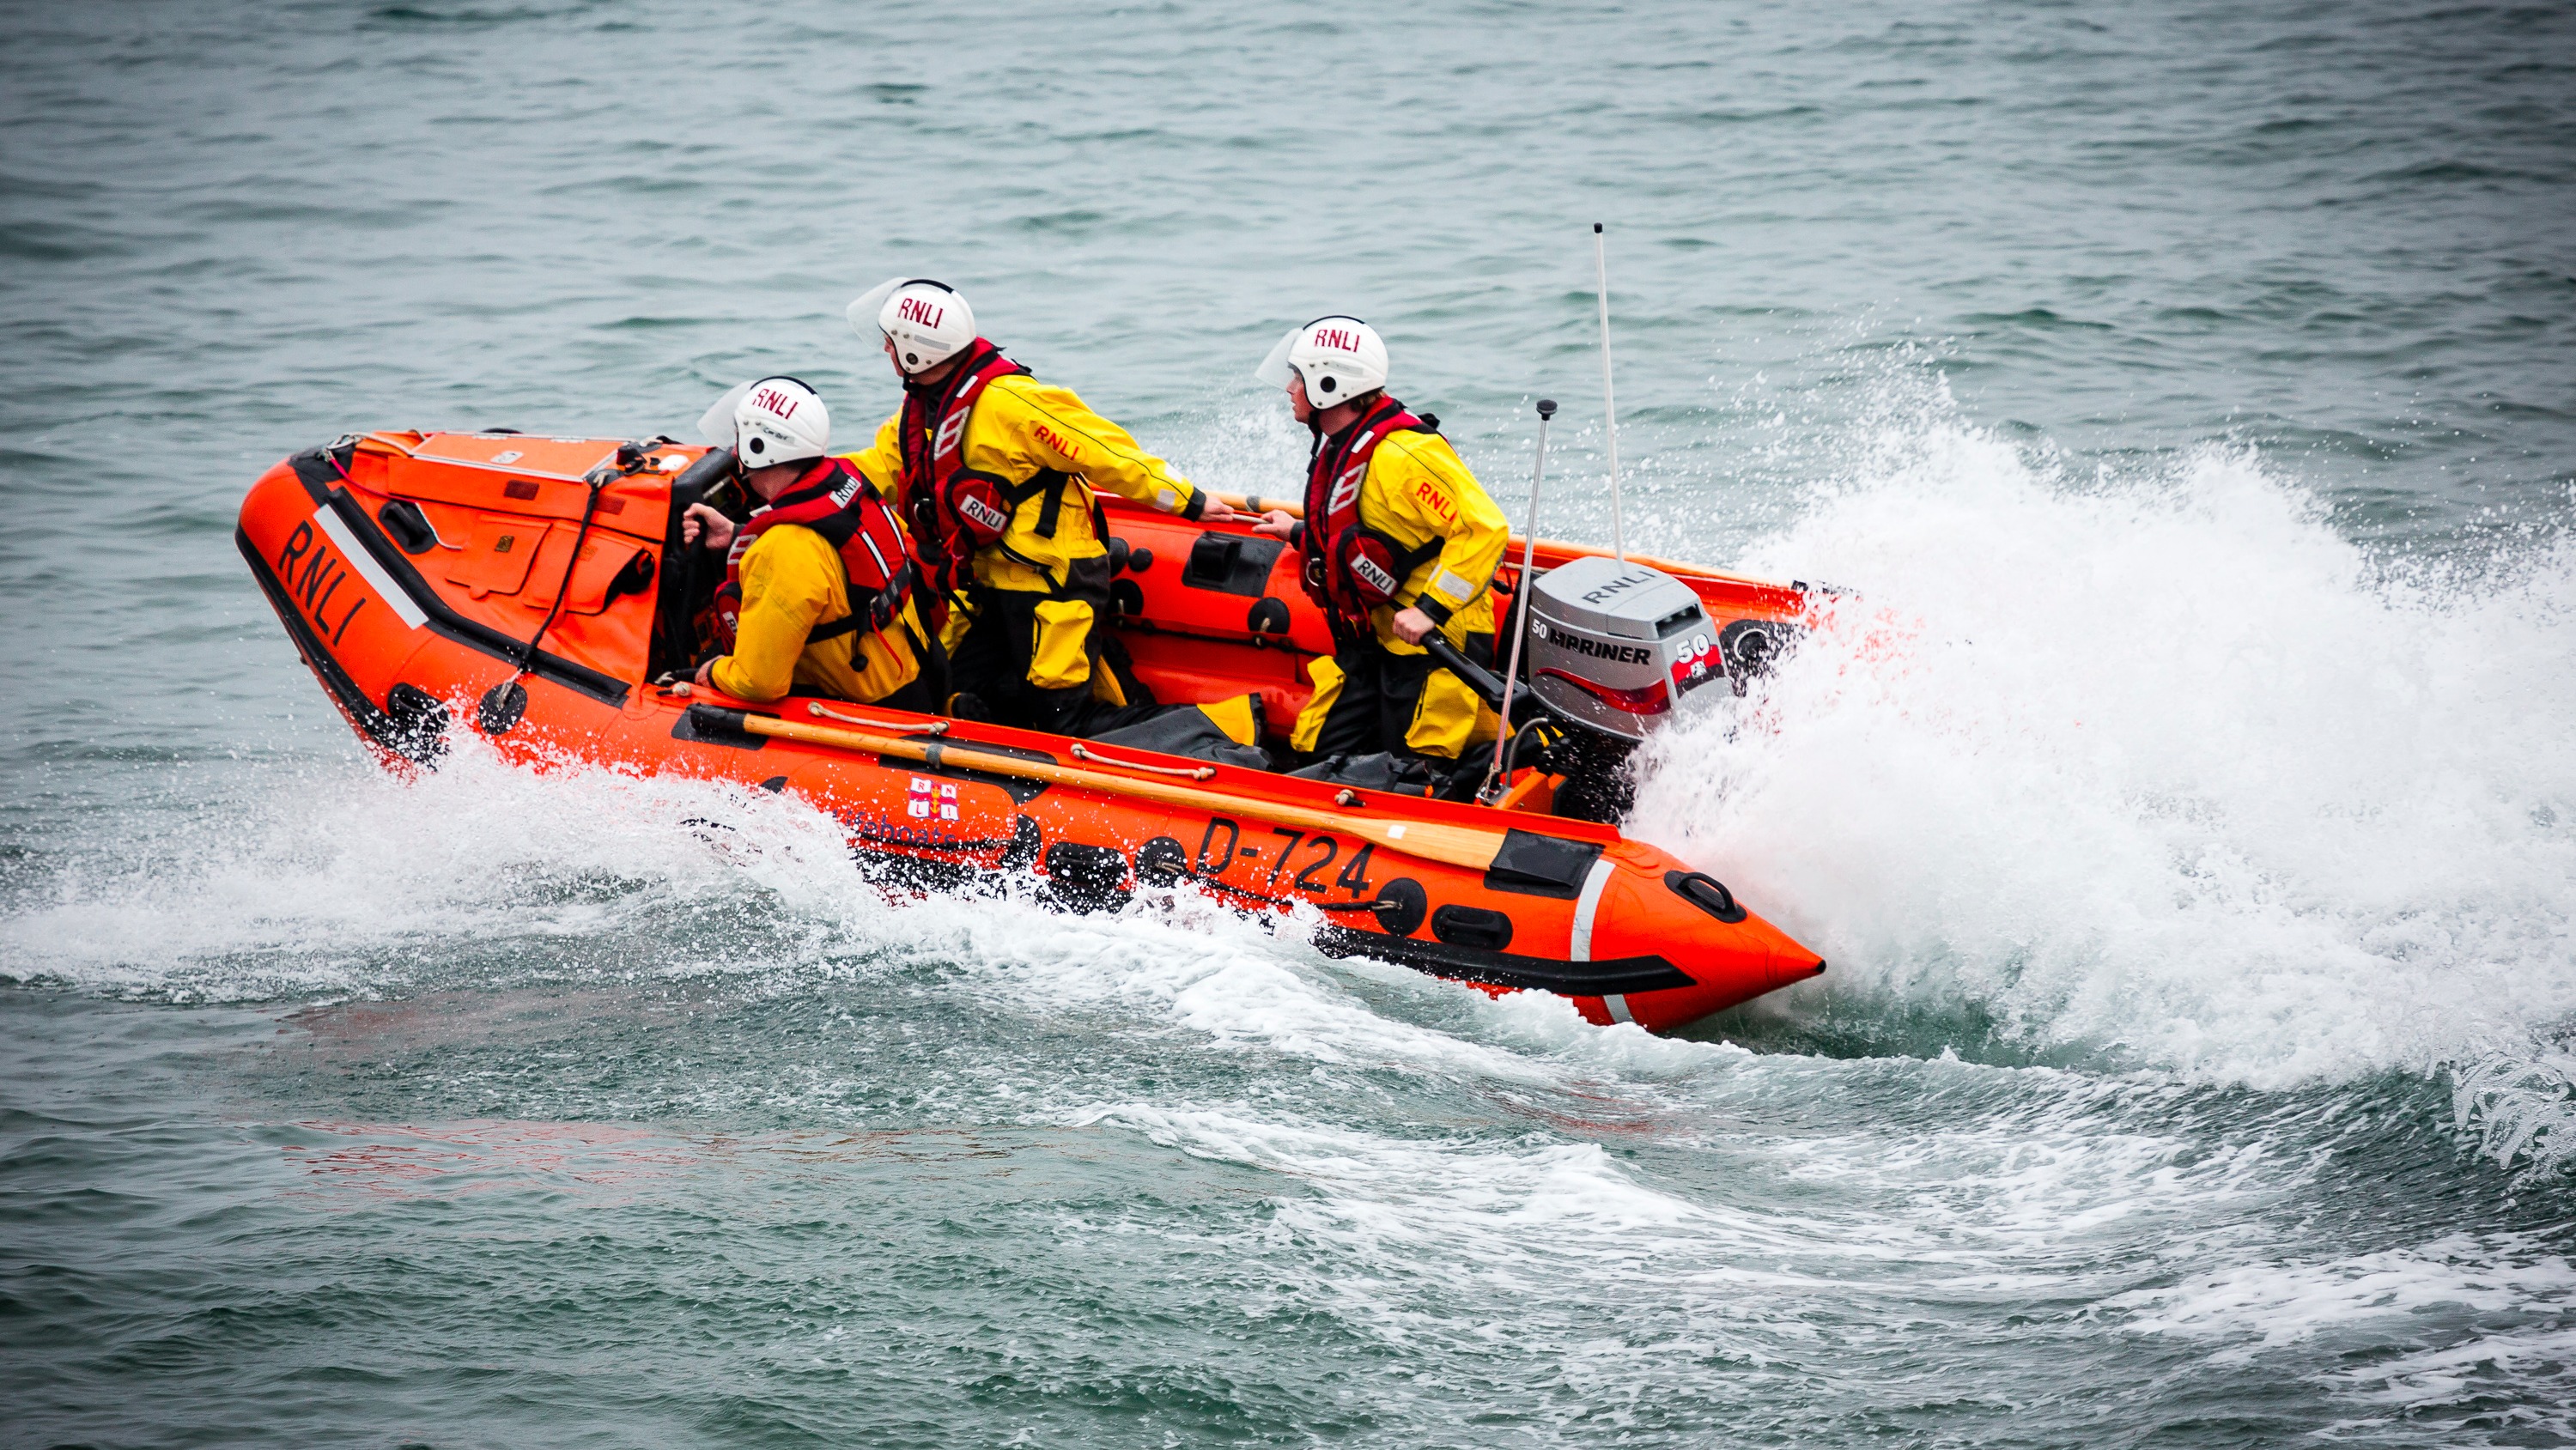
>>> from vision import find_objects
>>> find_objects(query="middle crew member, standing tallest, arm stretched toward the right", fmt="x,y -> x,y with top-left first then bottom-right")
850,278 -> 1226,734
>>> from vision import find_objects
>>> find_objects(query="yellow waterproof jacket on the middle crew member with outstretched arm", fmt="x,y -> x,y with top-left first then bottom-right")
850,373 -> 1208,603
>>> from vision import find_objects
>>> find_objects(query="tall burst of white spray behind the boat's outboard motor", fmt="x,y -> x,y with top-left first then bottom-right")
1633,384 -> 2576,1113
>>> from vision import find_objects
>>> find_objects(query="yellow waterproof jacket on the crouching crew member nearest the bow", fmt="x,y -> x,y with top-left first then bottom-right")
708,523 -> 922,706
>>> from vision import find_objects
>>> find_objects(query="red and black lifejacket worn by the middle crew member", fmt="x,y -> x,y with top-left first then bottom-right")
899,337 -> 1072,595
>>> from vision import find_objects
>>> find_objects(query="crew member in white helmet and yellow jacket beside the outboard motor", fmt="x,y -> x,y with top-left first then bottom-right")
1255,317 -> 1510,760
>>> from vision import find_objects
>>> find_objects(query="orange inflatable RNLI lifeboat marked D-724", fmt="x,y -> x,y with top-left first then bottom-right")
237,433 -> 1824,1030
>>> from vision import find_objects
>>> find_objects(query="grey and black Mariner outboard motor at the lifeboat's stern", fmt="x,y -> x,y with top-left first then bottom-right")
1522,556 -> 1726,822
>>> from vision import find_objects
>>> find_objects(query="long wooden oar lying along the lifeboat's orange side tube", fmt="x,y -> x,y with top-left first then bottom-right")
688,706 -> 1502,871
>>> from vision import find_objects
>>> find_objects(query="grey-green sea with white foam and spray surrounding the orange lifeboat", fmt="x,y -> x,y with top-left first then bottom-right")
0,0 -> 2576,1450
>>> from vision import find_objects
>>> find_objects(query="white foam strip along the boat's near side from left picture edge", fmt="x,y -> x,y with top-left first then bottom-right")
0,731 -> 1597,1102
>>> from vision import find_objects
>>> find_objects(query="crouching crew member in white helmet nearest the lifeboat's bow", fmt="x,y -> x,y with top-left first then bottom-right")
680,379 -> 938,713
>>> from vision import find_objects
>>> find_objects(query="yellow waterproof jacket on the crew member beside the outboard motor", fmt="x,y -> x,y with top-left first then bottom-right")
1360,433 -> 1512,654
